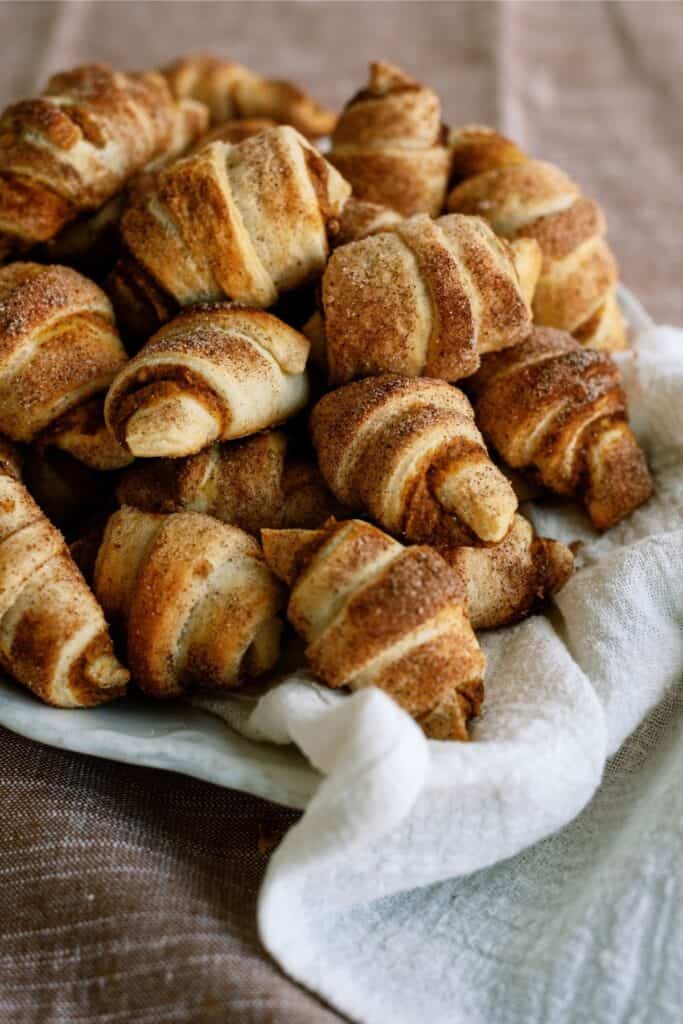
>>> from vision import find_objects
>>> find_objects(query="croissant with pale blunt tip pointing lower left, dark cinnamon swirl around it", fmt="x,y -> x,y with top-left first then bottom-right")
104,303 -> 308,458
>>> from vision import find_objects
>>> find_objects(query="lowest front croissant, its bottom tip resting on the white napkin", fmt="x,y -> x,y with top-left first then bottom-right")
262,519 -> 485,739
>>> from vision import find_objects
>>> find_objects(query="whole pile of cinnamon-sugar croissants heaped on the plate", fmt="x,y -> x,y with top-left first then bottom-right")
0,55 -> 652,739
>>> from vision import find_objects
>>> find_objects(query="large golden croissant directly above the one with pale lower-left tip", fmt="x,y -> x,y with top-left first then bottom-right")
108,121 -> 350,329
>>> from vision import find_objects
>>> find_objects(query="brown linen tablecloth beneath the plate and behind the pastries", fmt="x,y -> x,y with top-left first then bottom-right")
0,3 -> 683,1024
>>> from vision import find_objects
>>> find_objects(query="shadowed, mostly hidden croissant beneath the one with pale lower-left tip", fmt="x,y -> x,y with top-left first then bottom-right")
117,430 -> 348,535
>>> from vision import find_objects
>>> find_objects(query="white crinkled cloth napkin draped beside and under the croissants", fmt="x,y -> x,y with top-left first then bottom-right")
192,311 -> 683,1024
